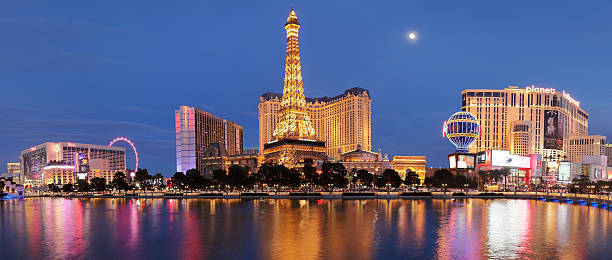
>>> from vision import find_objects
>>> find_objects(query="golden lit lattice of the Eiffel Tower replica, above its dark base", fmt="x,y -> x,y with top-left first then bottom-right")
273,10 -> 315,140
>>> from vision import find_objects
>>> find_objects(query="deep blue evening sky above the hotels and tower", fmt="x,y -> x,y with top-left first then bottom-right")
0,0 -> 612,176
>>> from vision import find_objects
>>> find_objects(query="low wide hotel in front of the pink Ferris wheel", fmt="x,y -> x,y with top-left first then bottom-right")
19,142 -> 126,186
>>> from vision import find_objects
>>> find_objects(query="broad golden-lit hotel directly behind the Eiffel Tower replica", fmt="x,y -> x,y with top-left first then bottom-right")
259,88 -> 372,159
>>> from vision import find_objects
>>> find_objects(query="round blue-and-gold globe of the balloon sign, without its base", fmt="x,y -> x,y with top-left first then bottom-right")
442,111 -> 481,152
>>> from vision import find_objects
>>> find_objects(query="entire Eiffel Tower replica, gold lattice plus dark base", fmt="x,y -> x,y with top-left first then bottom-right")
264,10 -> 327,168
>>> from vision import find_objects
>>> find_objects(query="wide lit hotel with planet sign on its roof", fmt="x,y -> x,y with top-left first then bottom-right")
461,86 -> 589,161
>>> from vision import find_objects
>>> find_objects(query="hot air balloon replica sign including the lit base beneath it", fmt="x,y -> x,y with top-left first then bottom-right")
442,111 -> 481,169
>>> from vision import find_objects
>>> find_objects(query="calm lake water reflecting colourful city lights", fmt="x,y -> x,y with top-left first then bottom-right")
0,198 -> 612,259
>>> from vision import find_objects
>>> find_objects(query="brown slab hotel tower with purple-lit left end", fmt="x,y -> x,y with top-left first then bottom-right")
174,106 -> 243,172
